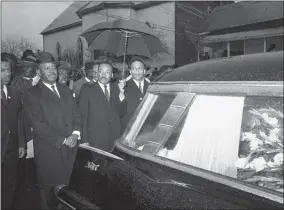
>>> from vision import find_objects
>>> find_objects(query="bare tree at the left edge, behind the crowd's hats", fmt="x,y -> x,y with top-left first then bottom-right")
1,36 -> 37,58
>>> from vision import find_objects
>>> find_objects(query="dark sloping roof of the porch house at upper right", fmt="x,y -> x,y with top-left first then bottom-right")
201,1 -> 284,32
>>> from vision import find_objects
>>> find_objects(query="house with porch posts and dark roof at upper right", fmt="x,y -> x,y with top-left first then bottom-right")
199,1 -> 284,60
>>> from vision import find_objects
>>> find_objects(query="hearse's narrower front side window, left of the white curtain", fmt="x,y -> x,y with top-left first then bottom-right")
122,92 -> 194,154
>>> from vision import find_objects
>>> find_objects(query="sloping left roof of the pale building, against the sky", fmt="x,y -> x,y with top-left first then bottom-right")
41,1 -> 88,35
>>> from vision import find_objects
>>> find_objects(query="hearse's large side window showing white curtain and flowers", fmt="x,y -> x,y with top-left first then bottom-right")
157,95 -> 283,193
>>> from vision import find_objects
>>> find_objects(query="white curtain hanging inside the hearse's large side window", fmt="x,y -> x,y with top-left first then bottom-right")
158,95 -> 244,178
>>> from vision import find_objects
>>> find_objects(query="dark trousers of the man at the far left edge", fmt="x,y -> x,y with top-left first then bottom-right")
1,154 -> 18,209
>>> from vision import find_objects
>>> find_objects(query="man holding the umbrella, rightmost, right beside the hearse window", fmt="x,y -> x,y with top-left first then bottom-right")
122,57 -> 149,130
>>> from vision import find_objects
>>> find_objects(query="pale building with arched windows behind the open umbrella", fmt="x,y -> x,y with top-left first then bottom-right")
41,1 -> 175,67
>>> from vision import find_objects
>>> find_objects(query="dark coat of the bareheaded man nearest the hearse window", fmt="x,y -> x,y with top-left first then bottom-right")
122,79 -> 149,130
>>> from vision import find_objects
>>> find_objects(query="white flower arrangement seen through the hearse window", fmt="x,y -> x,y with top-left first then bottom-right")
235,108 -> 283,193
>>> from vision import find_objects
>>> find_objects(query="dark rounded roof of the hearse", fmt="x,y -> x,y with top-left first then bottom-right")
154,51 -> 283,83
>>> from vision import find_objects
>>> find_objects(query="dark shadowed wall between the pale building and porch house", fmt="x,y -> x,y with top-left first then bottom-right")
175,1 -> 233,66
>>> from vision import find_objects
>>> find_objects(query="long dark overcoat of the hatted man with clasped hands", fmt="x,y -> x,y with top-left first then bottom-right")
24,81 -> 82,188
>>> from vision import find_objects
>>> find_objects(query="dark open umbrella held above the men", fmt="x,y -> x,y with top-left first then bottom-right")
81,19 -> 166,78
